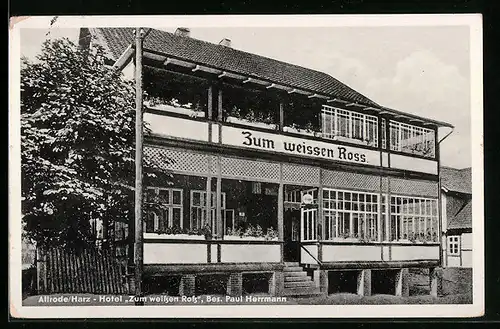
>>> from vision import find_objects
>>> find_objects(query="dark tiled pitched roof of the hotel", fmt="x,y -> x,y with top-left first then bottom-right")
91,28 -> 378,106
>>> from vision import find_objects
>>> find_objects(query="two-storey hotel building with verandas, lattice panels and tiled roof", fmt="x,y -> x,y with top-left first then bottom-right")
85,28 -> 451,296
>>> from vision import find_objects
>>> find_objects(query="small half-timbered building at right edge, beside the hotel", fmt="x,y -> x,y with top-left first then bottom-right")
441,167 -> 472,267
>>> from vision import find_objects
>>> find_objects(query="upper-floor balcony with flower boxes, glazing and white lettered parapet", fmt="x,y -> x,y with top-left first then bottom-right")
145,64 -> 437,174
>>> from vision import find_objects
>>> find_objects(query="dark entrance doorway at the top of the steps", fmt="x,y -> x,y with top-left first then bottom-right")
283,209 -> 300,262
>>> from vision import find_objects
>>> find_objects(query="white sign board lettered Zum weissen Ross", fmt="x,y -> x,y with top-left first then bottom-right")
221,126 -> 380,166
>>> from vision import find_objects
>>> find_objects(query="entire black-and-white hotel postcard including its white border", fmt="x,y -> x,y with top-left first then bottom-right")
9,14 -> 484,318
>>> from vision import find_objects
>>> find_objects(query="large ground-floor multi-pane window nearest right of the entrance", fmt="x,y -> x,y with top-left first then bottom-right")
323,189 -> 379,241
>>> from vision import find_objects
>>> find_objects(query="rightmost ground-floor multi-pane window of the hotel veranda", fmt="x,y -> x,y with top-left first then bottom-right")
389,196 -> 438,242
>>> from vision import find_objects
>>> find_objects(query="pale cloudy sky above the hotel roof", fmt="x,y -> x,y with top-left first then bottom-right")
21,25 -> 472,168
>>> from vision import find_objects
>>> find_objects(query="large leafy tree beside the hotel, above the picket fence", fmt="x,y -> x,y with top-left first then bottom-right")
21,39 -> 168,246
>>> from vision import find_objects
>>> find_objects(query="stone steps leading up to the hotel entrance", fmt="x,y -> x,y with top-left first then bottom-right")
283,262 -> 320,296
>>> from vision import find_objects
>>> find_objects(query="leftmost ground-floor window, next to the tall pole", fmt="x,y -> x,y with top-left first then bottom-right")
145,187 -> 183,233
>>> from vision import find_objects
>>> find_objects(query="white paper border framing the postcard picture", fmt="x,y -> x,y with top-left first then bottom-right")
9,14 -> 484,318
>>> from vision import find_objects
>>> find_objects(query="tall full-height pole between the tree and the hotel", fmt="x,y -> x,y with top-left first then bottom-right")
134,28 -> 144,305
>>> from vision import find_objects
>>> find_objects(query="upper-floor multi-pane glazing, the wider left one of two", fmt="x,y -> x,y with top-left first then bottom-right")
321,105 -> 378,146
